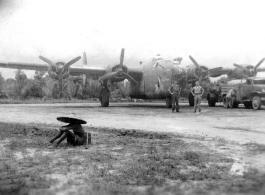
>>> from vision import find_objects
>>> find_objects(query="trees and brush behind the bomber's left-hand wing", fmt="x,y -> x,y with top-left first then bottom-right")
0,70 -> 100,99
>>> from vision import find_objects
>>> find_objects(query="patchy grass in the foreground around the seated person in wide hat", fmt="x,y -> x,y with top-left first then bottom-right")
0,123 -> 265,195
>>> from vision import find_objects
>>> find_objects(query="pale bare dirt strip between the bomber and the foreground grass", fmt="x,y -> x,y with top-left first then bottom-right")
0,103 -> 265,144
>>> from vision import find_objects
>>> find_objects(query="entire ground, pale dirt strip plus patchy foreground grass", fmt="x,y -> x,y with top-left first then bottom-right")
0,103 -> 265,194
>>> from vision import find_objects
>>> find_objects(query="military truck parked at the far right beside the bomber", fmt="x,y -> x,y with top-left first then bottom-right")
221,77 -> 265,110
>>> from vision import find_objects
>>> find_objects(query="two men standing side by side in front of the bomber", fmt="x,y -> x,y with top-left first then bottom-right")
168,81 -> 204,113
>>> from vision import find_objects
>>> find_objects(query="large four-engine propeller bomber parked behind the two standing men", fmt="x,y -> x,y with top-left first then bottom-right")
0,49 -> 222,107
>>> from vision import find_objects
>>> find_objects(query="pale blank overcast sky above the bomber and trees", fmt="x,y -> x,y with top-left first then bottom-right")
0,0 -> 265,78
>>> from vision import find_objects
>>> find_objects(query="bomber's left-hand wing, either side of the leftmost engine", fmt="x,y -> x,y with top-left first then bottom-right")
0,62 -> 106,76
